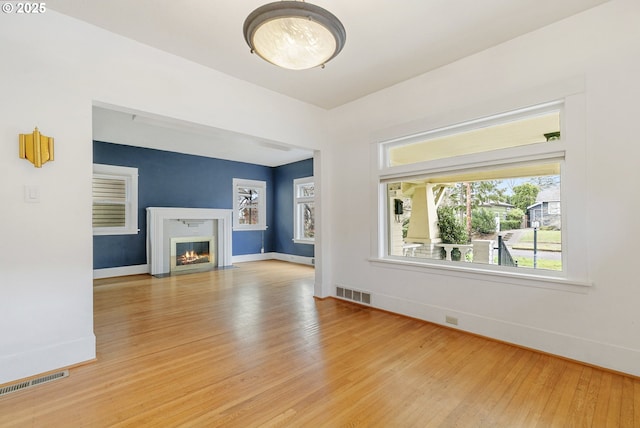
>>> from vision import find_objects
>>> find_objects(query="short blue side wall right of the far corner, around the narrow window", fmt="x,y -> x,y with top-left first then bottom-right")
274,159 -> 315,257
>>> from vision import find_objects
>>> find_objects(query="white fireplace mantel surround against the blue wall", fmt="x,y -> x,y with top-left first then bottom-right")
147,207 -> 233,275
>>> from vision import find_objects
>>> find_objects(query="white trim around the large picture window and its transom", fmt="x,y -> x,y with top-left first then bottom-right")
369,93 -> 592,292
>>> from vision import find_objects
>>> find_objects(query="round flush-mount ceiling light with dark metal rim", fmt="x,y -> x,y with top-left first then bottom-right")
244,1 -> 347,70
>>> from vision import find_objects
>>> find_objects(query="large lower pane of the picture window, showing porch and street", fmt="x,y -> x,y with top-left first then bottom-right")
387,164 -> 562,271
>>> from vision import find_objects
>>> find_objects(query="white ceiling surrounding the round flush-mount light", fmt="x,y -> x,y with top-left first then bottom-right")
47,0 -> 607,163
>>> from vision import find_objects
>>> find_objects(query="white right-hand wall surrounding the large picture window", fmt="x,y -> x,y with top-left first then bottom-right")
323,0 -> 640,375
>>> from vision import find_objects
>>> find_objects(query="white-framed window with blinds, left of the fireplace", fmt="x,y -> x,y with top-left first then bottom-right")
92,164 -> 138,235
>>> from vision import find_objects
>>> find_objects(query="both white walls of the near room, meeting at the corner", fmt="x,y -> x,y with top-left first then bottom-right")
0,0 -> 640,383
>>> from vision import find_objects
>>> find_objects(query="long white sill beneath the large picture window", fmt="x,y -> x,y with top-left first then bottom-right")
369,258 -> 593,294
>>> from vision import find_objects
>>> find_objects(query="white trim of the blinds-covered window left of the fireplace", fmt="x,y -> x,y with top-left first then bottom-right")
93,163 -> 140,236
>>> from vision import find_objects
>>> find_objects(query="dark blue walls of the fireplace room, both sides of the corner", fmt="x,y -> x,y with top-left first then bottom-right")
93,141 -> 313,269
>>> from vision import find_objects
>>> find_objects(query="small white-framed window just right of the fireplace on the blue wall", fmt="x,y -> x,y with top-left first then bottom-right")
233,178 -> 267,230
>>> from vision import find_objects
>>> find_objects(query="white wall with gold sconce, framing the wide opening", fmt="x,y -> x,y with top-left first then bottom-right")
0,11 -> 327,384
